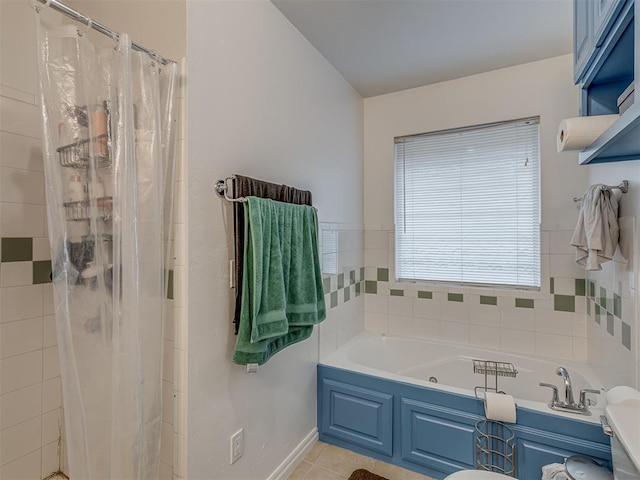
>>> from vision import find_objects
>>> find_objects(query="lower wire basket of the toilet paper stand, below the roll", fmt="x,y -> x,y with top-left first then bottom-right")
475,420 -> 516,477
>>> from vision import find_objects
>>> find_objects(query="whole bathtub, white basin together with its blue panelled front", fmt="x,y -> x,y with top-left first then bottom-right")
317,332 -> 611,480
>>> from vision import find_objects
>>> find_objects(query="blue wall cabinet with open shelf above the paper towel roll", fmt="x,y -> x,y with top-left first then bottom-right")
574,0 -> 640,164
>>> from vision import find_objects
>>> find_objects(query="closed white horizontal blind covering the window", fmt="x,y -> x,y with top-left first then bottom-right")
395,118 -> 540,289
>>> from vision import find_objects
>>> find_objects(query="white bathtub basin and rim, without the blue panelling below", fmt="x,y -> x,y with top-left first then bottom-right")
320,332 -> 605,423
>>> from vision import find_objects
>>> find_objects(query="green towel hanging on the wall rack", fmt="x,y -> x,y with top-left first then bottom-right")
233,197 -> 326,365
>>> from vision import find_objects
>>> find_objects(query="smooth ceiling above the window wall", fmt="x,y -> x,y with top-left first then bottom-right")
272,0 -> 573,97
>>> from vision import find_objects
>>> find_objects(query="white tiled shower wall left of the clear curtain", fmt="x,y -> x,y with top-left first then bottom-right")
0,71 -> 68,479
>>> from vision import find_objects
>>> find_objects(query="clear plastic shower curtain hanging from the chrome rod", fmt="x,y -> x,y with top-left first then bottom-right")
37,15 -> 177,480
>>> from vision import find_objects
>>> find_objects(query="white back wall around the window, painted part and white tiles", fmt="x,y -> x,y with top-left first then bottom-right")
364,55 -> 588,360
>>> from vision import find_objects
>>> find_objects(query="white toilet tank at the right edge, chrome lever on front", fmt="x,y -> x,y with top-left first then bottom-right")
605,399 -> 640,480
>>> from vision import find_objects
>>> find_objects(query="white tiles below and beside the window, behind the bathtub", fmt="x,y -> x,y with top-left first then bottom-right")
365,230 -> 587,361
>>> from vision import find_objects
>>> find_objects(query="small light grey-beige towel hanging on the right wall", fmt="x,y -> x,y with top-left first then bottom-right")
571,184 -> 620,270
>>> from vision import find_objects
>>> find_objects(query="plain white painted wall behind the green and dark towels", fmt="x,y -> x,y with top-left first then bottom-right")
187,1 -> 363,480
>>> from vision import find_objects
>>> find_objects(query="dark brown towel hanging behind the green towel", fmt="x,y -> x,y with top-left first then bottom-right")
233,174 -> 311,335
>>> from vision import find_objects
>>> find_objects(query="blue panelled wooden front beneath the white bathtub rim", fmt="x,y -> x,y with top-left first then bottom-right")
318,365 -> 611,479
